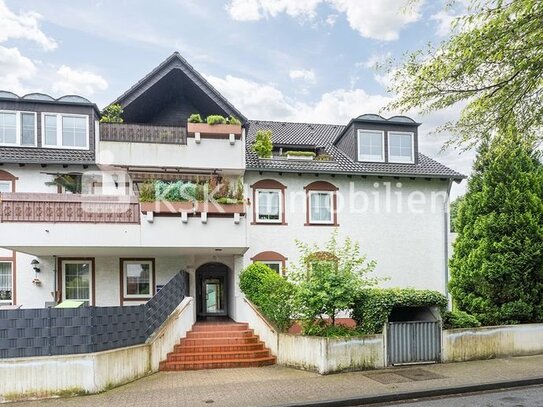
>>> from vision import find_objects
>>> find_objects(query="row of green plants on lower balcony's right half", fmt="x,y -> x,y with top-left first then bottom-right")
139,176 -> 244,205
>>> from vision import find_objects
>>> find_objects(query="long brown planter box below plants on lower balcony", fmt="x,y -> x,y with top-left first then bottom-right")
140,201 -> 245,216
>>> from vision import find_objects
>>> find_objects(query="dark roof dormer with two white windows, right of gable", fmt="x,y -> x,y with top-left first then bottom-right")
334,114 -> 420,164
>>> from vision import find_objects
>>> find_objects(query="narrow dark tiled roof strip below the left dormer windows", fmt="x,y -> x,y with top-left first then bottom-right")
0,147 -> 94,164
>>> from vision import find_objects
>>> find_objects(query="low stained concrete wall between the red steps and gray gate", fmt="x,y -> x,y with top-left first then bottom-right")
278,334 -> 385,374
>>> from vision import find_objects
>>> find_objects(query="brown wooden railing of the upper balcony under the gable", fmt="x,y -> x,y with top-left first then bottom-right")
100,123 -> 187,144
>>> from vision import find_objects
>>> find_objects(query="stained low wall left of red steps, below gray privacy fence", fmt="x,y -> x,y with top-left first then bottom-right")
0,297 -> 194,402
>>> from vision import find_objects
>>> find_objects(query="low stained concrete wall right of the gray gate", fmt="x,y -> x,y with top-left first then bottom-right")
442,324 -> 543,363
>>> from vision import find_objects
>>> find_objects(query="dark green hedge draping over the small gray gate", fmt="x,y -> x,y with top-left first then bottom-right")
351,288 -> 447,334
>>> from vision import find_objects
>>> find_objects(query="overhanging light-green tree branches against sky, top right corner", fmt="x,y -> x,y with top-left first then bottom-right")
390,0 -> 543,145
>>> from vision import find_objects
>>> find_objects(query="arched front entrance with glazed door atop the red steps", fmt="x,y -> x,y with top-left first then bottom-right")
196,263 -> 229,317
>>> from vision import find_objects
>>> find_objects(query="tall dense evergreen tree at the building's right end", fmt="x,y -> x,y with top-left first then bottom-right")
450,128 -> 543,325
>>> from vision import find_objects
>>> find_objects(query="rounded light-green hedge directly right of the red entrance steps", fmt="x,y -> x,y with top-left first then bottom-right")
239,262 -> 295,332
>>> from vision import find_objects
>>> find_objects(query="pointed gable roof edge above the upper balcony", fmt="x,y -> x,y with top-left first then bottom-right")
112,52 -> 247,123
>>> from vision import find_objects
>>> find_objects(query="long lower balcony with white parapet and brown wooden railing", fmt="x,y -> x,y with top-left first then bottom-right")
0,193 -> 247,256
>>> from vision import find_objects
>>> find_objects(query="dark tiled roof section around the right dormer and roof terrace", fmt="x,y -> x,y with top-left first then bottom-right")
246,120 -> 465,179
